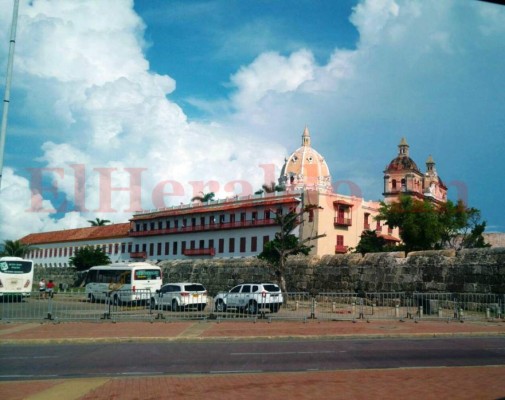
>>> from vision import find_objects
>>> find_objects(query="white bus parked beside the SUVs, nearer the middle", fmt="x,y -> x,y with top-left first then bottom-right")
86,262 -> 162,305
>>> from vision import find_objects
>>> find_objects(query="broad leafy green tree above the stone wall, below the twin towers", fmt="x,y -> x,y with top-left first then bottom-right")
376,196 -> 485,252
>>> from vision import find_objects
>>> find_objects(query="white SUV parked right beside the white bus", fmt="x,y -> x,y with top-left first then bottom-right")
150,282 -> 207,311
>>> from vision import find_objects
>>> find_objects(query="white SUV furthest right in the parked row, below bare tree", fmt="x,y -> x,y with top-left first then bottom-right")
214,283 -> 284,314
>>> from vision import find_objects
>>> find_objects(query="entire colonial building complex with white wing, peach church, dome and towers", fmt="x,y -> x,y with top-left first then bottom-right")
21,128 -> 422,267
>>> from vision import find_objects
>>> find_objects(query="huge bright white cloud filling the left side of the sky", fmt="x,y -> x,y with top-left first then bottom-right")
0,0 -> 283,238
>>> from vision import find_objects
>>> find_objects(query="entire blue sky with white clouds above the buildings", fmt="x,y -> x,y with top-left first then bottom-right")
0,0 -> 505,240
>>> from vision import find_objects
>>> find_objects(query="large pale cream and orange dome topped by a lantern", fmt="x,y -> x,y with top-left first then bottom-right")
279,127 -> 331,190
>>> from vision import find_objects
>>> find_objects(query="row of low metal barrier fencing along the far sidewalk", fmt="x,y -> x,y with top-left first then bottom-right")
0,291 -> 505,322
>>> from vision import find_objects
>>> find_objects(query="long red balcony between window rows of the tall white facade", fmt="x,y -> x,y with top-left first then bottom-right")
128,218 -> 275,237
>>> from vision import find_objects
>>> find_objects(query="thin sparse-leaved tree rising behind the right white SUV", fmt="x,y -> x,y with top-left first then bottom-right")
258,205 -> 326,301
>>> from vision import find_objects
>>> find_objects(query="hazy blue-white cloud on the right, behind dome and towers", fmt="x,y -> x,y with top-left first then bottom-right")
224,0 -> 505,222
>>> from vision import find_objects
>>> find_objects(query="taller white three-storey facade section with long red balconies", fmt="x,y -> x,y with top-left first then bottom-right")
129,191 -> 300,260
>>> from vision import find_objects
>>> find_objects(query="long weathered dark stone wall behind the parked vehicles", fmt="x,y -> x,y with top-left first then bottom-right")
36,248 -> 505,295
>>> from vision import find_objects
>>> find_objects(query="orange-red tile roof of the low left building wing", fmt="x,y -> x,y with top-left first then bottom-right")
20,223 -> 130,245
